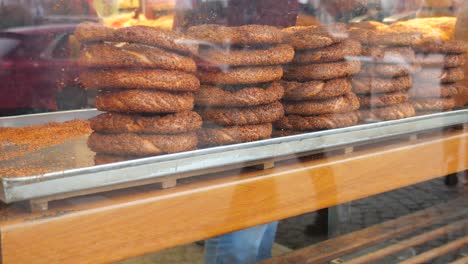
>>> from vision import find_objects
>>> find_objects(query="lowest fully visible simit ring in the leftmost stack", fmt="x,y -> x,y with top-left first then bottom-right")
88,132 -> 198,156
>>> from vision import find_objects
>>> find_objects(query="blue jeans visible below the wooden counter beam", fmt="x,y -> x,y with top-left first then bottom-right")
205,222 -> 278,264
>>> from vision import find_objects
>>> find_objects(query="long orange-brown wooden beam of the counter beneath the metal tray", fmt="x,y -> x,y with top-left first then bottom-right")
0,131 -> 468,264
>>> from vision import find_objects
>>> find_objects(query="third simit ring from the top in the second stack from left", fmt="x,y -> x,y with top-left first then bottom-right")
198,66 -> 283,85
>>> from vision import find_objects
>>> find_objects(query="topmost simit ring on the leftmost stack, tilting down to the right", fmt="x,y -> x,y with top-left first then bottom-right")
114,26 -> 198,54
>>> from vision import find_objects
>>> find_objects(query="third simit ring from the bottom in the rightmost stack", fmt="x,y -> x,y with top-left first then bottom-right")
413,67 -> 465,83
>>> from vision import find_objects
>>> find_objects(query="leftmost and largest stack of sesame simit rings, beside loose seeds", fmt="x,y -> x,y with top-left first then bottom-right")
75,23 -> 202,163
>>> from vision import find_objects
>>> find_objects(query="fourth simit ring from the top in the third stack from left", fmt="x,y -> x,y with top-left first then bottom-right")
281,78 -> 352,101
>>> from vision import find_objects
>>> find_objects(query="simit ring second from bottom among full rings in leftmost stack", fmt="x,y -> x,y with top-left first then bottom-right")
89,111 -> 203,134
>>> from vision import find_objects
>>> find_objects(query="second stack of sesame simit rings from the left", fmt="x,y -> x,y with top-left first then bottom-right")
187,25 -> 294,146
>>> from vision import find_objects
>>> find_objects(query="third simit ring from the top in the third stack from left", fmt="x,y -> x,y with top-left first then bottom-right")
283,61 -> 361,81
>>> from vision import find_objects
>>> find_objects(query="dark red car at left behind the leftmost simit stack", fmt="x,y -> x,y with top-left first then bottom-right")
0,24 -> 86,114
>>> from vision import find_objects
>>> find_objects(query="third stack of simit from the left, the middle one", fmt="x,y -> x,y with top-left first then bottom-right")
274,24 -> 361,136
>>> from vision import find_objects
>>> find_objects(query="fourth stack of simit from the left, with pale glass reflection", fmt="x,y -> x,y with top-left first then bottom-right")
350,21 -> 418,122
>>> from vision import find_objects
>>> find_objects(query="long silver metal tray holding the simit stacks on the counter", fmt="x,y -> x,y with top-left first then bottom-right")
0,109 -> 468,203
